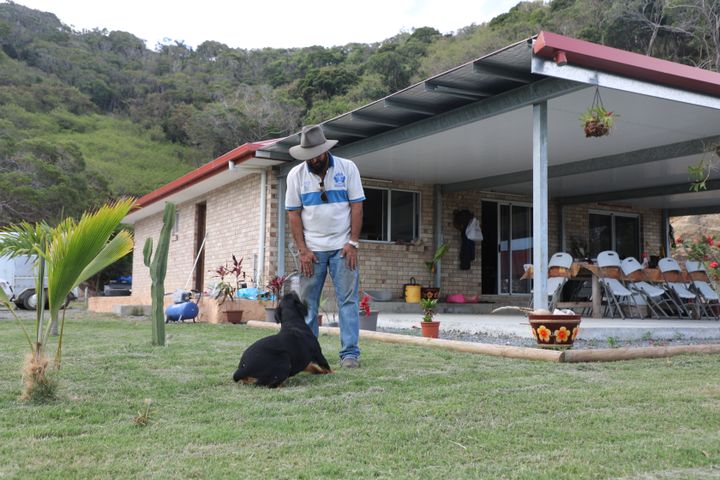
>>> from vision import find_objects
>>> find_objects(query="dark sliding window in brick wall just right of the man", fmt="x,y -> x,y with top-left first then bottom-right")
360,188 -> 420,242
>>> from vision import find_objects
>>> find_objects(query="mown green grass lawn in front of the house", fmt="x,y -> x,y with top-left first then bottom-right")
0,311 -> 720,480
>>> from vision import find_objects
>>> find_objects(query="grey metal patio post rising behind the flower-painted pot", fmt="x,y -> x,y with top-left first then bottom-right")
533,102 -> 548,310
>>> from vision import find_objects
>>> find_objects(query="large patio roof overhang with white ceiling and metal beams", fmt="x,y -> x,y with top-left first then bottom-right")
258,32 -> 720,213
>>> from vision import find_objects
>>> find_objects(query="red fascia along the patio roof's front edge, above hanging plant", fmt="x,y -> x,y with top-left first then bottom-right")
533,32 -> 720,96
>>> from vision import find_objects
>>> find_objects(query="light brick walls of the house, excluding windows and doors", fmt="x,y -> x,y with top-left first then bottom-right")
128,172 -> 662,304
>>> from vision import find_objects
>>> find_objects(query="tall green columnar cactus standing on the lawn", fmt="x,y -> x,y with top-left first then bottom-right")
143,202 -> 175,345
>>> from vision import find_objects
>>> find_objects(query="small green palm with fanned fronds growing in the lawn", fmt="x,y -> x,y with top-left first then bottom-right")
0,199 -> 135,398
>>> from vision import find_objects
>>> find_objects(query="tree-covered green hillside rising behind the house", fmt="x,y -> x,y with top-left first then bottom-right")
0,0 -> 720,225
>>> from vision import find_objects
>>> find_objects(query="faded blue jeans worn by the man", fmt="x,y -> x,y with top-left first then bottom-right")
300,250 -> 360,359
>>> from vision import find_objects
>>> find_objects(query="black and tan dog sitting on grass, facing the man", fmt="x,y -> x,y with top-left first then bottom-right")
233,293 -> 332,388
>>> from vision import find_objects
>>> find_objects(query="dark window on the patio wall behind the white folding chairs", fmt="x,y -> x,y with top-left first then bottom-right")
589,212 -> 640,258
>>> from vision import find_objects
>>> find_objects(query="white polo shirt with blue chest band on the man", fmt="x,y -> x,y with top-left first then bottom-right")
285,152 -> 365,252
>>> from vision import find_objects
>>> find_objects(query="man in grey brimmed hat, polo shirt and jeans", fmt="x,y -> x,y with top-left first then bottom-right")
285,125 -> 365,368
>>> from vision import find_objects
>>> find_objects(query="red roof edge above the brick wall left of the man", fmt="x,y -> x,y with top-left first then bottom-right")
134,140 -> 275,209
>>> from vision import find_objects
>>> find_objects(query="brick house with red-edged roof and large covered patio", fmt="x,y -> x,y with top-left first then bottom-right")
98,32 -> 720,320
